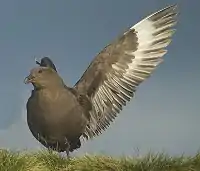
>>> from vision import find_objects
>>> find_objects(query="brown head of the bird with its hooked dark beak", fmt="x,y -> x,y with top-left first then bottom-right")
24,66 -> 63,88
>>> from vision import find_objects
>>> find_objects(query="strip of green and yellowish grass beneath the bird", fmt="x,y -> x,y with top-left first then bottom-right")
0,149 -> 200,171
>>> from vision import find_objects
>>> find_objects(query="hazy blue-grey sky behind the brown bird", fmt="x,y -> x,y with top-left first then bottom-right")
0,0 -> 200,155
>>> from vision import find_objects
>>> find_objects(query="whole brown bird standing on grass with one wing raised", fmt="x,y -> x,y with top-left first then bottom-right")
24,4 -> 178,156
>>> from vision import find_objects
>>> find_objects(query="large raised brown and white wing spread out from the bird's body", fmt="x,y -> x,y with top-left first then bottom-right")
74,5 -> 177,139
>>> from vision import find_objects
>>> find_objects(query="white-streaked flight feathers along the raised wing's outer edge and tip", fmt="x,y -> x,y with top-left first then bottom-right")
84,5 -> 177,139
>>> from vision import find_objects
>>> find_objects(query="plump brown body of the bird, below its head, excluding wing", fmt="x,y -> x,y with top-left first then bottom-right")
27,86 -> 88,152
